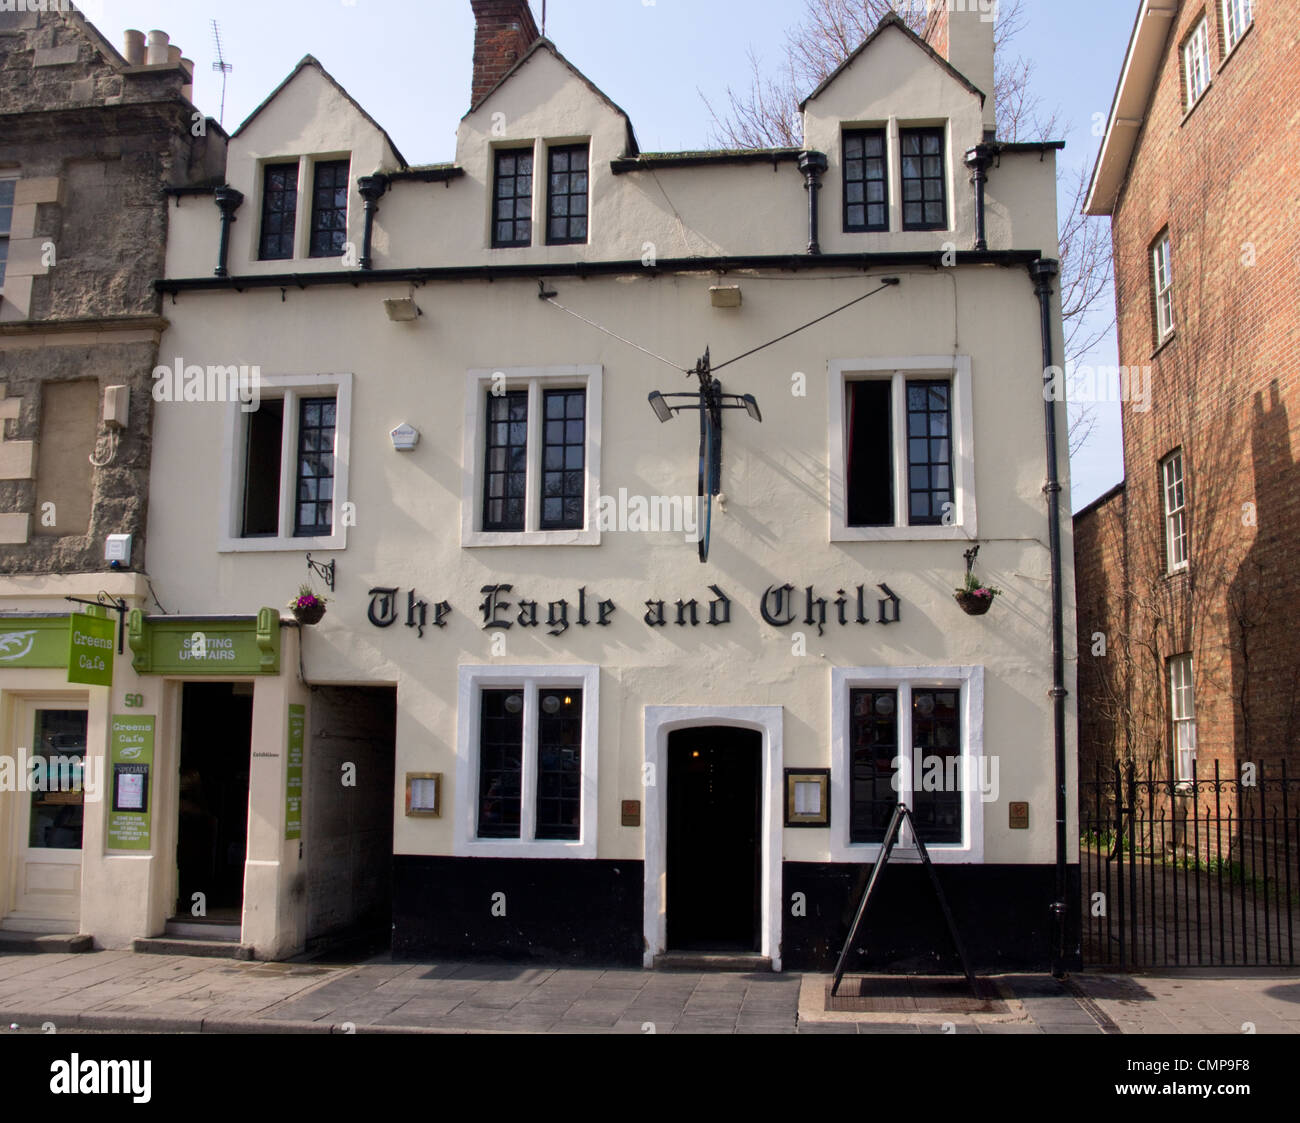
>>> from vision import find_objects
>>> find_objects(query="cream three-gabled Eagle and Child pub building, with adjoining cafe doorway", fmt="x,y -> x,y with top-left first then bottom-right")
2,0 -> 1079,970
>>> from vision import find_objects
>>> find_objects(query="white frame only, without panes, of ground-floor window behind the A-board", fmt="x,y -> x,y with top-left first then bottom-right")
831,665 -> 984,863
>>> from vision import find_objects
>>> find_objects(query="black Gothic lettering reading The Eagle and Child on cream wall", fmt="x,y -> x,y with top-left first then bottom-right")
367,582 -> 902,638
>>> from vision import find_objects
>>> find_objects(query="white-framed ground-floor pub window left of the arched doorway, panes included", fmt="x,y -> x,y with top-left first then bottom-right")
456,667 -> 599,857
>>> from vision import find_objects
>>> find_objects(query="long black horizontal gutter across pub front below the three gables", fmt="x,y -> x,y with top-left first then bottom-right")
153,250 -> 1043,296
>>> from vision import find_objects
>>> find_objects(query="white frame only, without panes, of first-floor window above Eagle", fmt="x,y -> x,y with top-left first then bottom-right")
460,365 -> 603,547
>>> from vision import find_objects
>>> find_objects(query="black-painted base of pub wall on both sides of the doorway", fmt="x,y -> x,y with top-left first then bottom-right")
393,854 -> 1079,972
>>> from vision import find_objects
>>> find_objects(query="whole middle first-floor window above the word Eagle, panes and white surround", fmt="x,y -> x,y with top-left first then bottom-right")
462,367 -> 601,546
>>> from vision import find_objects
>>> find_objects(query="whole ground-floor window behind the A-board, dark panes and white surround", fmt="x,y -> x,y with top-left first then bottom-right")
831,667 -> 982,860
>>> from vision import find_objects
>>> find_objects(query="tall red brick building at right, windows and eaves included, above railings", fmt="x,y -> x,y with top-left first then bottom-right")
1075,0 -> 1300,811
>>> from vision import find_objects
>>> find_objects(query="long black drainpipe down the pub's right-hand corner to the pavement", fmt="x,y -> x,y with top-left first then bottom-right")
1030,257 -> 1069,979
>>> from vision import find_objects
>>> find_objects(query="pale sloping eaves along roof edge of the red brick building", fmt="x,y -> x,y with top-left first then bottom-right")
1083,0 -> 1178,214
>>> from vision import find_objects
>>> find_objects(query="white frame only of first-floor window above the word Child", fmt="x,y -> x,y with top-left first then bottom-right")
828,355 -> 978,542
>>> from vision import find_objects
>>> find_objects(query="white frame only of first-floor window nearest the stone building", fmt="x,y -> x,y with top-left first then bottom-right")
217,373 -> 352,554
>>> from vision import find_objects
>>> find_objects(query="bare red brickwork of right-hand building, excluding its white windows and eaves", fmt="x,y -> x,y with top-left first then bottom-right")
1079,3 -> 1300,795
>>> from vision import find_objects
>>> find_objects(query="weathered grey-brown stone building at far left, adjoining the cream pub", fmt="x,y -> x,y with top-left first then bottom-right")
0,4 -> 225,927
